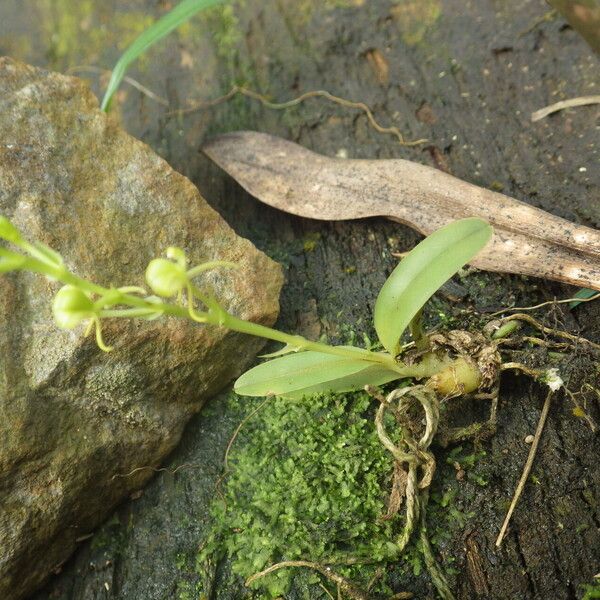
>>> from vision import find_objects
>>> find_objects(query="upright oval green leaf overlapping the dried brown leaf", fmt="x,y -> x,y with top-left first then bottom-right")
375,218 -> 492,356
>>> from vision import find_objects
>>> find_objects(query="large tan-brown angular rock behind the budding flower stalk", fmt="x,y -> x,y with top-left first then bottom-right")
0,59 -> 282,600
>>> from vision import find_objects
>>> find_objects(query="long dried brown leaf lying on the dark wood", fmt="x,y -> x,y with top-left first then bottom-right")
204,131 -> 600,290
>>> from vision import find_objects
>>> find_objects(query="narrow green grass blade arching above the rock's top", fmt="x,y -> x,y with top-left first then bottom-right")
100,0 -> 223,112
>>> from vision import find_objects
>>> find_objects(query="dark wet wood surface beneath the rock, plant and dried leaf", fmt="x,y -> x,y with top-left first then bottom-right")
0,0 -> 600,600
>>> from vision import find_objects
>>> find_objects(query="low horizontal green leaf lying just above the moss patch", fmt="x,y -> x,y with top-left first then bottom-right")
234,351 -> 400,398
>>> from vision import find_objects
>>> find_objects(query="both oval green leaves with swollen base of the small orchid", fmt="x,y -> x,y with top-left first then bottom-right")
235,219 -> 492,397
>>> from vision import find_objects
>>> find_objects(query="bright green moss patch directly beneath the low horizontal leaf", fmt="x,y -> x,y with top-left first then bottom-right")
199,393 -> 401,598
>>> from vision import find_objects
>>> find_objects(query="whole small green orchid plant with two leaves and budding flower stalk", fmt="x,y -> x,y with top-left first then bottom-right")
0,216 -> 492,397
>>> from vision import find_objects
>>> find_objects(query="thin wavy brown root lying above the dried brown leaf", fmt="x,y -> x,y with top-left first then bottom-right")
167,85 -> 428,146
